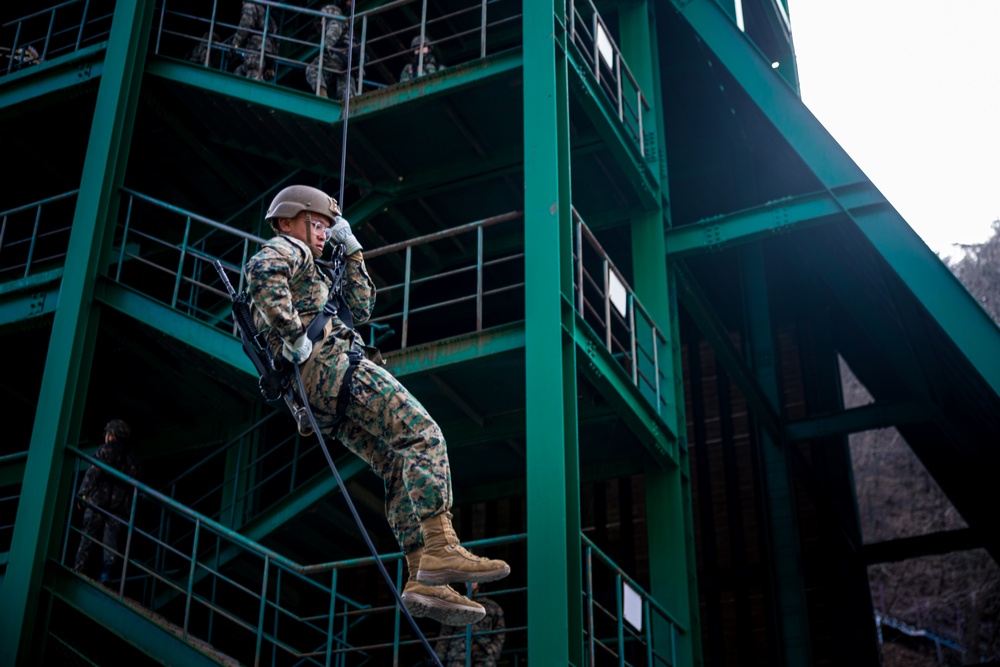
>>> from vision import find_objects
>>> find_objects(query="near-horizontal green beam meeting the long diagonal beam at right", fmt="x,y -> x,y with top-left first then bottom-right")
666,183 -> 888,260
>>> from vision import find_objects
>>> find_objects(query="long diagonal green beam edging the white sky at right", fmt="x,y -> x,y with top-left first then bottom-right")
673,0 -> 1000,402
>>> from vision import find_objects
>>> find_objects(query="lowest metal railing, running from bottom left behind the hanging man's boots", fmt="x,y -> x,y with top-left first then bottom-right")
61,446 -> 526,665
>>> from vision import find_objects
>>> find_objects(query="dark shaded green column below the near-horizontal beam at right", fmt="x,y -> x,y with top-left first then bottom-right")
740,243 -> 812,667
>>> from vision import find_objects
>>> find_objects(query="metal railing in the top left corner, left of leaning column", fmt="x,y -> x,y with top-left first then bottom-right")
0,0 -> 114,74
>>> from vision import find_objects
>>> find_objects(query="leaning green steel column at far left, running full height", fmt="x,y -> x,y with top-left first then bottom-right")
0,0 -> 153,665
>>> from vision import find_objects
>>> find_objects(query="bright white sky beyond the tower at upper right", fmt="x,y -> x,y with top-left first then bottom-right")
788,0 -> 1000,255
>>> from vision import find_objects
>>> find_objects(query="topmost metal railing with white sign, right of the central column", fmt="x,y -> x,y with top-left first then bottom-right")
567,0 -> 651,156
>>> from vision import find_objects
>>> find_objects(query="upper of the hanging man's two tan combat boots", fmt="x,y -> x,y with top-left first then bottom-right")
417,512 -> 510,586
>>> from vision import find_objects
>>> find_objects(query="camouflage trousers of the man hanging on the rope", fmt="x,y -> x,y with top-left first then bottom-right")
302,345 -> 452,553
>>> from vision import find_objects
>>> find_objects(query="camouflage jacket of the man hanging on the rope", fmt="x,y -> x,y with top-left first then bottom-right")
246,235 -> 375,369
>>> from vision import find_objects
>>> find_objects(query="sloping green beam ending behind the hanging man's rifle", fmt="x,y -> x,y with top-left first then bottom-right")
94,280 -> 257,377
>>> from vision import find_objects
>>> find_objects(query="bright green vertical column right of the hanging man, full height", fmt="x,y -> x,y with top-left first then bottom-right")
523,0 -> 583,667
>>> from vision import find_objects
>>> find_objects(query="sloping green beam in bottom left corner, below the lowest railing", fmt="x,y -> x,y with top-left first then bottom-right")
45,563 -> 220,667
